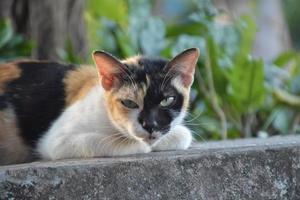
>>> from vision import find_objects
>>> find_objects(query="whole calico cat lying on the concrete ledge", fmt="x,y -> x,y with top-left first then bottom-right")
0,48 -> 199,164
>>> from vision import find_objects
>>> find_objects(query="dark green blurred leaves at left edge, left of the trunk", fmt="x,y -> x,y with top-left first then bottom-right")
0,19 -> 33,62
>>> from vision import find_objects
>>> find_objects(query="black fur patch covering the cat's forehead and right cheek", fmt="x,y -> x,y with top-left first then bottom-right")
125,57 -> 184,133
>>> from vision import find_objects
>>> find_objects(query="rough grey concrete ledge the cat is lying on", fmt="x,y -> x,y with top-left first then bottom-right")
0,136 -> 300,200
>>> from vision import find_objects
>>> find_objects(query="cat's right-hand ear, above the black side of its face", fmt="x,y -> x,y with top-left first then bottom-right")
165,48 -> 200,87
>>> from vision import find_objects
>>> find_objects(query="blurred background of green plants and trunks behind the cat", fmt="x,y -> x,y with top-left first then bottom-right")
0,0 -> 300,140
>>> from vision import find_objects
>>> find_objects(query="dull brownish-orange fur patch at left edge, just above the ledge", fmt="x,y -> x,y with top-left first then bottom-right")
0,108 -> 29,165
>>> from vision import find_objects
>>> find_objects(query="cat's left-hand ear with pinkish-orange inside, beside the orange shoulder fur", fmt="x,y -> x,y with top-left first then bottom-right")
93,51 -> 125,90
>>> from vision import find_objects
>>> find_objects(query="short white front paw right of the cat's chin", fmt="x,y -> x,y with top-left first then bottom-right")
152,125 -> 193,151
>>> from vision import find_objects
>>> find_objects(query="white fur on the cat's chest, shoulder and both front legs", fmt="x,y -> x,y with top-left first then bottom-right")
37,85 -> 192,159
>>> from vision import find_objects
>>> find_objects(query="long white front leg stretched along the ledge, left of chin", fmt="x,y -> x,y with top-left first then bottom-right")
38,133 -> 151,160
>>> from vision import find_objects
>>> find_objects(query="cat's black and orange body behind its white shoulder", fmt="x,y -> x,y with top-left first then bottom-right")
0,61 -> 96,163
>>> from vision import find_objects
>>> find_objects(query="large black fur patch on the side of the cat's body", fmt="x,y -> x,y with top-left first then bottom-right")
0,62 -> 74,146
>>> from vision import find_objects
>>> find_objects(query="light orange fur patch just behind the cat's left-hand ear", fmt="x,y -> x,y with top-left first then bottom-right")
64,66 -> 99,106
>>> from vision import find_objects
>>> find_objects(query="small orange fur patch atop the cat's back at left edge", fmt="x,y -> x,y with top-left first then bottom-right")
0,63 -> 22,94
